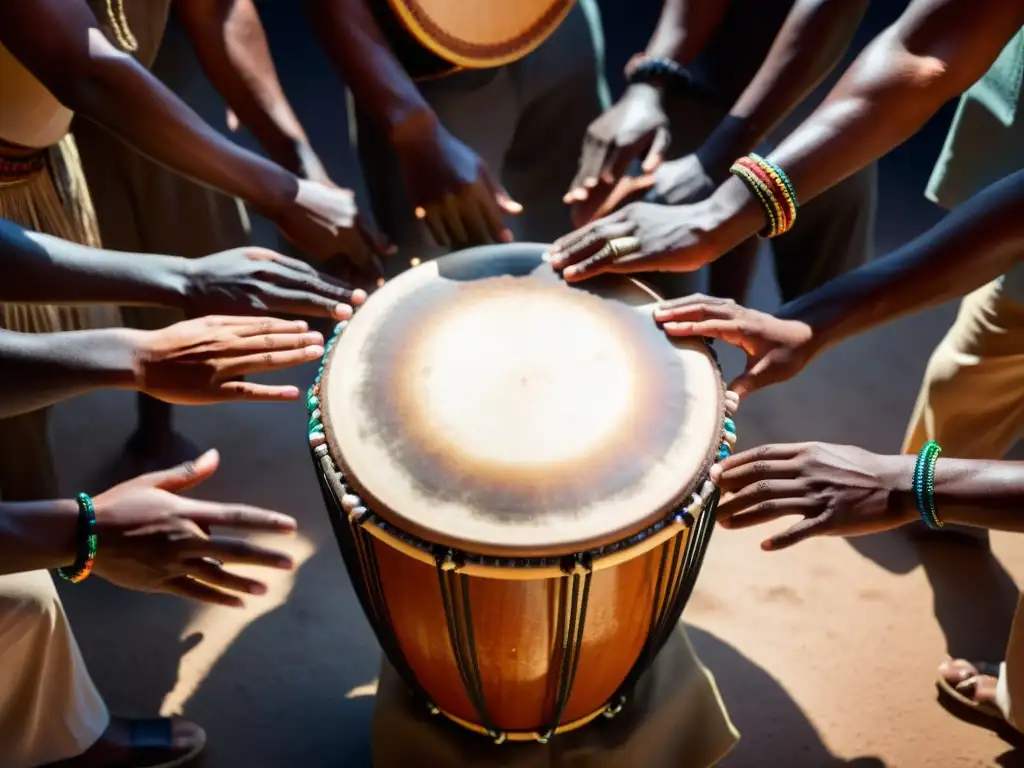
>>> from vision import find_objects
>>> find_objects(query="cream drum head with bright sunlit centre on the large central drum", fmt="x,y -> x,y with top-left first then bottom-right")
322,243 -> 724,557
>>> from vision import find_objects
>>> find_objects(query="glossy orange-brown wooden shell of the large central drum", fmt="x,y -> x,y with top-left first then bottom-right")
314,446 -> 718,741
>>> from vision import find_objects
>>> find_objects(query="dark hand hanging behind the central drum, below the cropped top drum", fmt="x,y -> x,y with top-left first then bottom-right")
392,115 -> 522,248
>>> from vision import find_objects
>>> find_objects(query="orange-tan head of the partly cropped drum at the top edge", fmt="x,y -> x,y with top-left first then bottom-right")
390,0 -> 575,69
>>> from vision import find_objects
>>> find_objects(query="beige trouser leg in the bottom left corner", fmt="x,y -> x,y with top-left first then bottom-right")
0,570 -> 110,768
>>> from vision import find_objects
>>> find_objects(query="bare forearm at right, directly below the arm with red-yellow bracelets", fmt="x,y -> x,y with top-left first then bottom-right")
778,170 -> 1024,353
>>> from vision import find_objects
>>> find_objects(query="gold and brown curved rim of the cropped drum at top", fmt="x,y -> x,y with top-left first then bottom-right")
388,0 -> 575,70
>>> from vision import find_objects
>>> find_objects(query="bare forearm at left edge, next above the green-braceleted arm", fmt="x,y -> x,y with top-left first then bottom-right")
0,329 -> 141,419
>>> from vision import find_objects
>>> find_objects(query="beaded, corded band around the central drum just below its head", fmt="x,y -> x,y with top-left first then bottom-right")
306,308 -> 736,568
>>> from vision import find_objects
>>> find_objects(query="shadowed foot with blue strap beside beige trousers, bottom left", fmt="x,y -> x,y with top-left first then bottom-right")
49,718 -> 206,768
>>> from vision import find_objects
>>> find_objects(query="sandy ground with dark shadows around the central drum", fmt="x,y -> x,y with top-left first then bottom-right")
44,3 -> 1024,768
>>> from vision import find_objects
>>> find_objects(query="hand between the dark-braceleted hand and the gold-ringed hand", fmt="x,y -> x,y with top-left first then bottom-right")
572,155 -> 716,226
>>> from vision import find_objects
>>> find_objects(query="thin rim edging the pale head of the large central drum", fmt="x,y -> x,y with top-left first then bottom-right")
308,249 -> 734,567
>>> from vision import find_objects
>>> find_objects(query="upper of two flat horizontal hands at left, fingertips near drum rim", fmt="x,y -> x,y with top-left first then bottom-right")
184,248 -> 367,319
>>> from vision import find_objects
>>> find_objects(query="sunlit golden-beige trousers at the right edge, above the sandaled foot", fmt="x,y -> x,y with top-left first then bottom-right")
903,280 -> 1024,727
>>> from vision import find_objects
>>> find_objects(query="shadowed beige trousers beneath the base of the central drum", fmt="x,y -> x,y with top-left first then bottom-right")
371,625 -> 739,768
